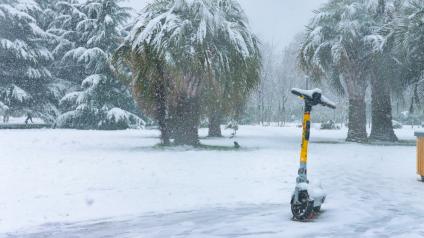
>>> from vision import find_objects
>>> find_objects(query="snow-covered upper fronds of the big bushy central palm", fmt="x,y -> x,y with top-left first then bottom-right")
127,0 -> 257,69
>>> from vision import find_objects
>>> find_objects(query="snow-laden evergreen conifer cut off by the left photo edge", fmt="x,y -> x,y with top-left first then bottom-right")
0,0 -> 58,121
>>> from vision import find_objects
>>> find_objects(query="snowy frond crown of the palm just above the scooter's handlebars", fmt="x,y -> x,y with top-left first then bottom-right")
299,0 -> 385,81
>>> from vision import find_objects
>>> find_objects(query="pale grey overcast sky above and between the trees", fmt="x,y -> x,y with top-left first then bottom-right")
122,0 -> 327,47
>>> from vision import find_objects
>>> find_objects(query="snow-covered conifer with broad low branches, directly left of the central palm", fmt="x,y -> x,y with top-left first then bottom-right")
53,0 -> 144,129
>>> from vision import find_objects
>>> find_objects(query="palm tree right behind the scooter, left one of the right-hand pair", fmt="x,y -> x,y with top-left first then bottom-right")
299,0 -> 384,142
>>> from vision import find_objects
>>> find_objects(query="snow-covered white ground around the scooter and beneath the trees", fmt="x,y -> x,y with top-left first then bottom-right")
0,126 -> 424,238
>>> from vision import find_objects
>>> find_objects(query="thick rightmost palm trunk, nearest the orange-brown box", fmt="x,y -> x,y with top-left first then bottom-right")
370,77 -> 398,142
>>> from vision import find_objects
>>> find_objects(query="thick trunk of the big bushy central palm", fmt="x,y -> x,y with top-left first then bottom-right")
173,97 -> 200,146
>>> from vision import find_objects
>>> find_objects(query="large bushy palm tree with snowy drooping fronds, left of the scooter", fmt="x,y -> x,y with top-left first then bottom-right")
115,0 -> 259,145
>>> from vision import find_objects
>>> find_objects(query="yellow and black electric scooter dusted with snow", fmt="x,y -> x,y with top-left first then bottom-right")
290,88 -> 336,221
